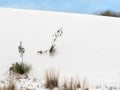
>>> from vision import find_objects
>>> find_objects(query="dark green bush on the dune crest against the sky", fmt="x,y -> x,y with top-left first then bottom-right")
98,10 -> 120,17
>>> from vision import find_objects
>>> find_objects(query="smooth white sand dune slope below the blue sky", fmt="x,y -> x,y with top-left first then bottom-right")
0,8 -> 120,83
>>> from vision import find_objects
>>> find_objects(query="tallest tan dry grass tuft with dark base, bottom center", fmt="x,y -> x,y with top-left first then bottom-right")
45,69 -> 59,88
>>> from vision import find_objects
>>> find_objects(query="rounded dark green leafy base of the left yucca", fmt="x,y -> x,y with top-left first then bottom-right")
10,62 -> 31,74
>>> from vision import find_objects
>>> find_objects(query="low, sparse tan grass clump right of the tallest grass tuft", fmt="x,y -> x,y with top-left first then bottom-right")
62,78 -> 81,90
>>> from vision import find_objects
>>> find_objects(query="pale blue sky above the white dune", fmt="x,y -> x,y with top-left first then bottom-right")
0,0 -> 120,14
